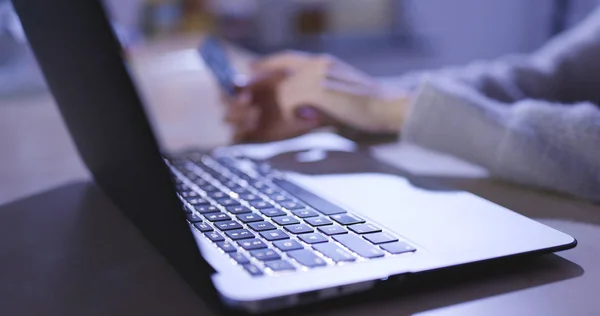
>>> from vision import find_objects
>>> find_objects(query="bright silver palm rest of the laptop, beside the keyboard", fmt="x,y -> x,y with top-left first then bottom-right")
286,172 -> 565,260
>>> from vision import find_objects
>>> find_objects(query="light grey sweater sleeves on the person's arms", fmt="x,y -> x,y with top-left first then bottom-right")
403,10 -> 600,201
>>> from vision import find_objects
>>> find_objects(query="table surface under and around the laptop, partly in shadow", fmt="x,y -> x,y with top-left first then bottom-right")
0,33 -> 600,315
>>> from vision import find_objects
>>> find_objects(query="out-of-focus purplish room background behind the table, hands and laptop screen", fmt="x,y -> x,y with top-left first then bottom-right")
0,0 -> 597,96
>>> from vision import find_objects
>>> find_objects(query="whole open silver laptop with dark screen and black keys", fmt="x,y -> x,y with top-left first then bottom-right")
14,0 -> 576,313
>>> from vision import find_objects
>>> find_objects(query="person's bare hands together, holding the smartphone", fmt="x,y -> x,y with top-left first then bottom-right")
224,52 -> 408,142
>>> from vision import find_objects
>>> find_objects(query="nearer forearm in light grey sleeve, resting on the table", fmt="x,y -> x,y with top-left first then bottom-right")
403,81 -> 600,201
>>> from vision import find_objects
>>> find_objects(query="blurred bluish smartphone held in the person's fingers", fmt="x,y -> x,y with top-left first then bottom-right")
198,35 -> 238,96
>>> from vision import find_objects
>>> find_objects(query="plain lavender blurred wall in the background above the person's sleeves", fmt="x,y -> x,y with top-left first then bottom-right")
396,0 -> 599,65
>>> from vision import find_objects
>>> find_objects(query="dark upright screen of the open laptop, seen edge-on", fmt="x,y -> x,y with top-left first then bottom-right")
13,0 -> 223,308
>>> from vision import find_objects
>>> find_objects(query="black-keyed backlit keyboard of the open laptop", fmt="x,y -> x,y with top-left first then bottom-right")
169,155 -> 416,276
